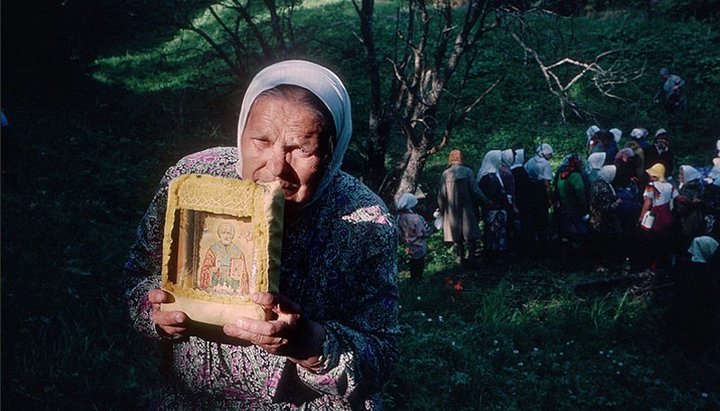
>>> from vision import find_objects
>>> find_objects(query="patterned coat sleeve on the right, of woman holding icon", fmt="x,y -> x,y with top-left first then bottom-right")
298,204 -> 399,402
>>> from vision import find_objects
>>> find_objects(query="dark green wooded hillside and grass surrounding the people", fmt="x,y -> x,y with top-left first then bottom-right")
1,0 -> 720,410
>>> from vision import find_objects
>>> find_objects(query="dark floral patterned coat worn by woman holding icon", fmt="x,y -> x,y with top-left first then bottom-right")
124,147 -> 399,410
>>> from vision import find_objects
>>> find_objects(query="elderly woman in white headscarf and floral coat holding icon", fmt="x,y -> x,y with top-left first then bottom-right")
125,60 -> 399,410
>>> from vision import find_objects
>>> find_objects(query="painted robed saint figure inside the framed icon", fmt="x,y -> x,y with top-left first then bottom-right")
198,223 -> 250,295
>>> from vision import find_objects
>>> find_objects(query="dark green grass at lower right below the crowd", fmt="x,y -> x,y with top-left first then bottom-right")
385,260 -> 720,410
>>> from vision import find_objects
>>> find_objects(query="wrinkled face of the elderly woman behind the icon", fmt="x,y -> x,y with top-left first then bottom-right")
241,96 -> 324,217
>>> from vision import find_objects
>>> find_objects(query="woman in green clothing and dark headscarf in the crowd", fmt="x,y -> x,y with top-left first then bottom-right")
556,154 -> 589,248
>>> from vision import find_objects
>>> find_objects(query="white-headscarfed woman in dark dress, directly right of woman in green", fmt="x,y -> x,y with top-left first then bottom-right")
590,165 -> 622,272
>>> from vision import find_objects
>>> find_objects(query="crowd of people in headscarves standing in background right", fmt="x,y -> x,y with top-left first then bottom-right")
430,126 -> 720,278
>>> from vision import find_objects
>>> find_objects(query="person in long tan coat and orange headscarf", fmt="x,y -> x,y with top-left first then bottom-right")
437,150 -> 486,264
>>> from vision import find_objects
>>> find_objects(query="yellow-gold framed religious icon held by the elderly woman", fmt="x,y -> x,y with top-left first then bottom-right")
161,174 -> 285,325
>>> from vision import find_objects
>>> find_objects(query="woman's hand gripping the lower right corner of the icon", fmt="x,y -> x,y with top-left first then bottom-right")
223,292 -> 325,366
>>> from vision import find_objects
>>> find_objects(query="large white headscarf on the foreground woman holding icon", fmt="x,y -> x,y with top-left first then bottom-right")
236,60 -> 352,204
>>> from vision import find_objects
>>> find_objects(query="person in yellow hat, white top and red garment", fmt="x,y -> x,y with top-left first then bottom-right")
638,163 -> 678,272
